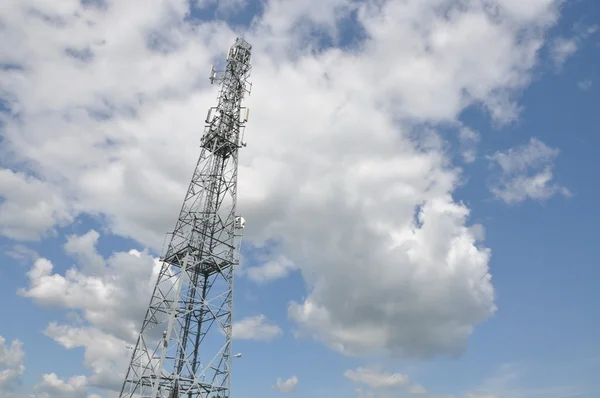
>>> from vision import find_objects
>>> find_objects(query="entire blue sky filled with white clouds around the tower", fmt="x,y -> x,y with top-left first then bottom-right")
0,0 -> 600,398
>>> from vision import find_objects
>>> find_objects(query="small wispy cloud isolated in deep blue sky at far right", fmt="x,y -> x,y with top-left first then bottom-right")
488,138 -> 570,203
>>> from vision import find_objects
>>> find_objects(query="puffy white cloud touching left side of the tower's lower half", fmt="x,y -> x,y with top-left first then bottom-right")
19,230 -> 159,346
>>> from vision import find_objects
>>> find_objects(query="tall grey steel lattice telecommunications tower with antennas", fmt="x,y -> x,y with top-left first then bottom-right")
120,38 -> 252,398
